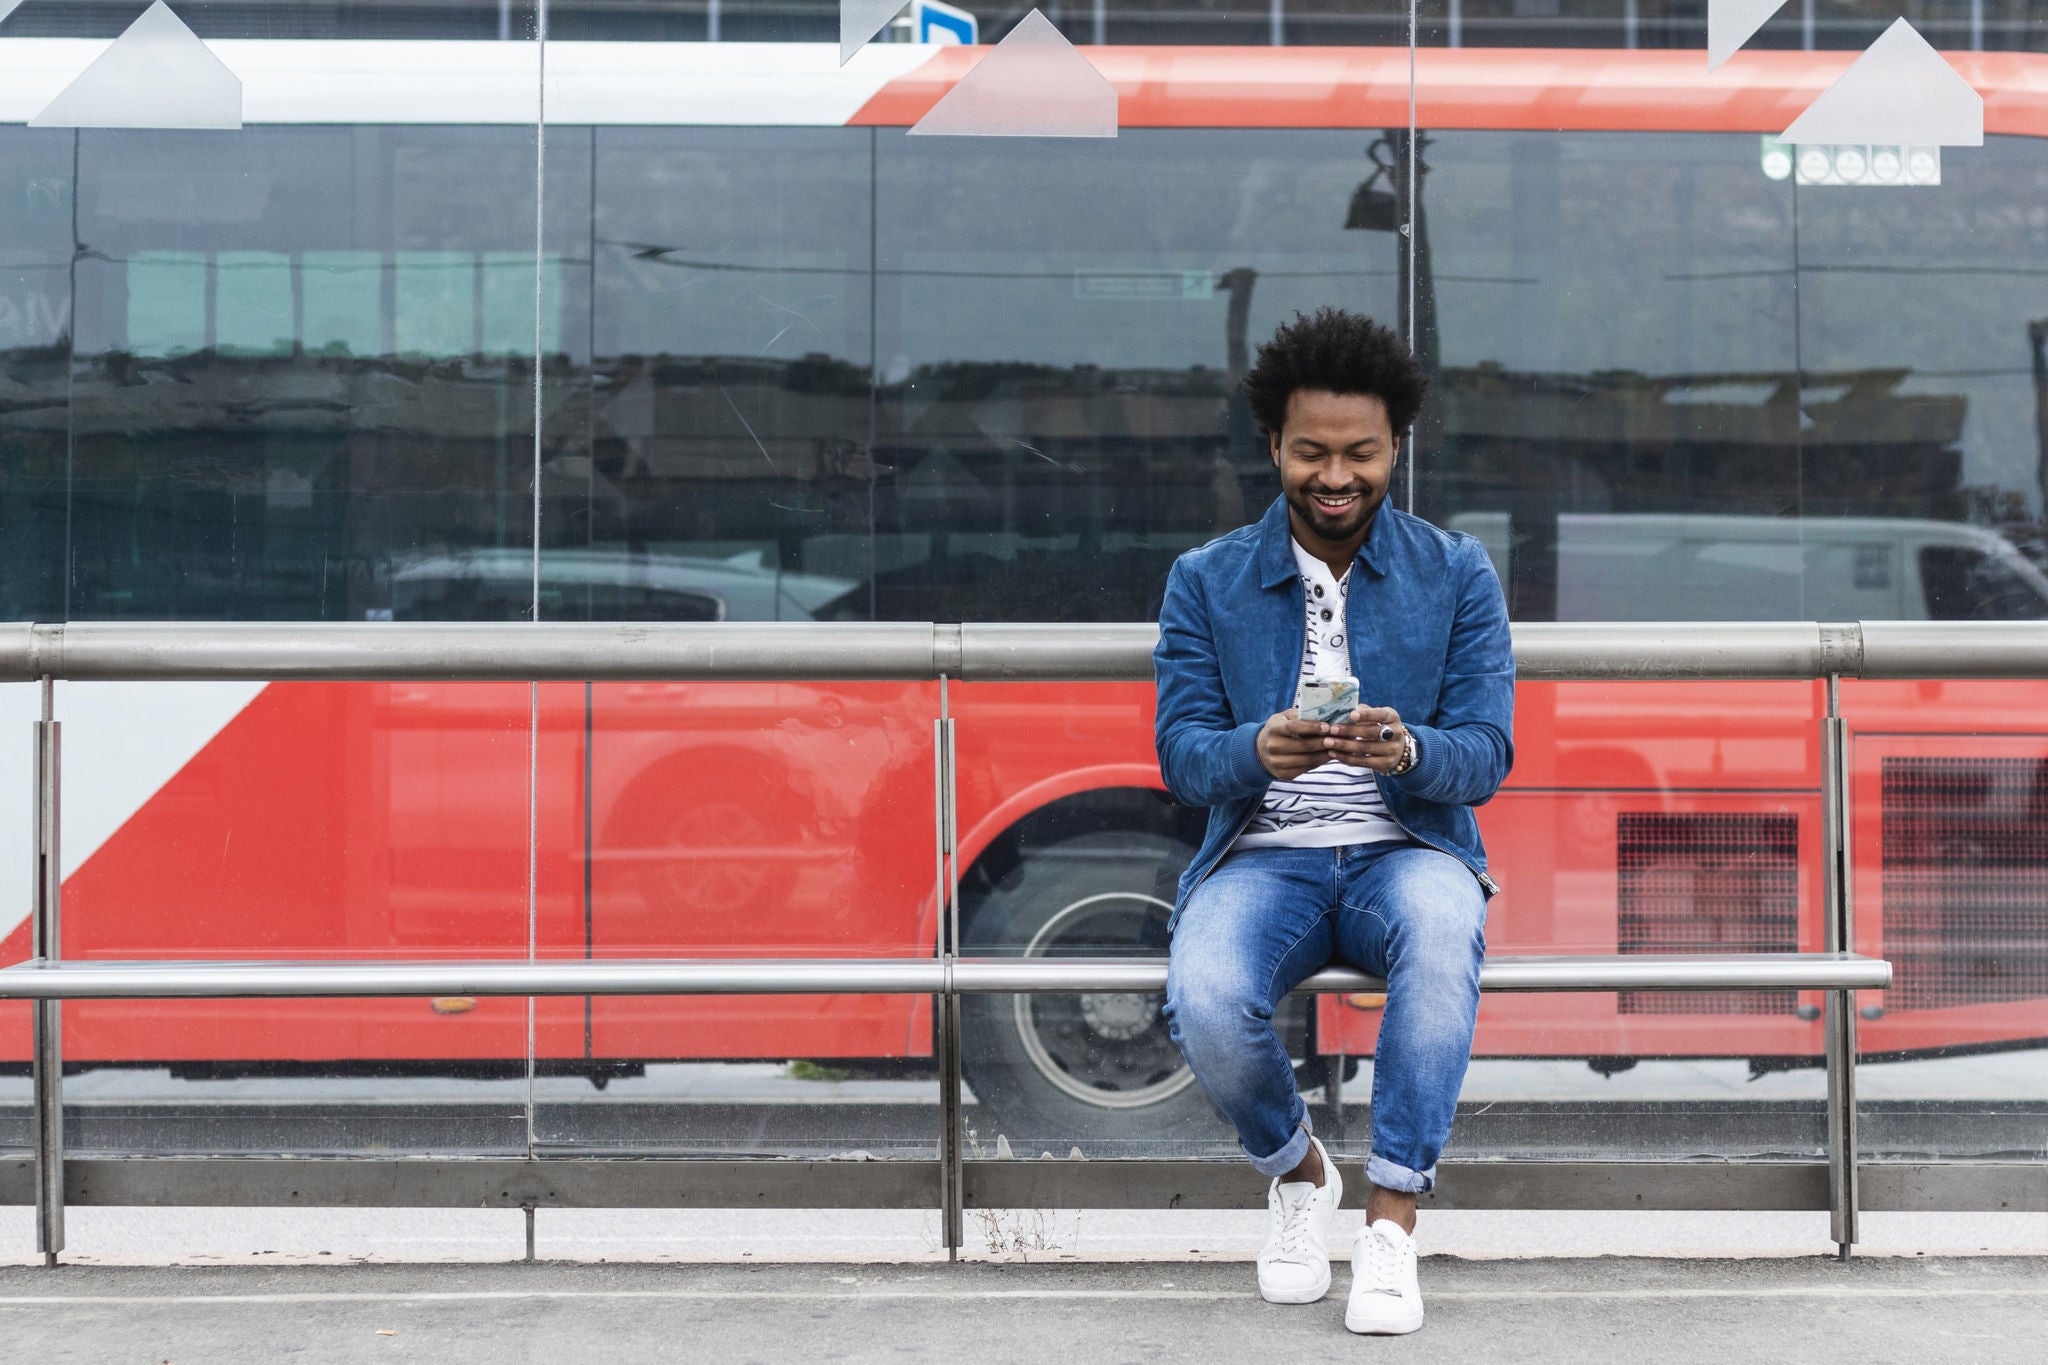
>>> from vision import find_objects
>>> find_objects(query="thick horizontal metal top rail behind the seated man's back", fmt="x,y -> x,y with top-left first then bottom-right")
12,620 -> 2048,681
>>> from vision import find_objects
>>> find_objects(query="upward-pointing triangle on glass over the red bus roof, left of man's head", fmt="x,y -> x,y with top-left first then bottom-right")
909,10 -> 1116,137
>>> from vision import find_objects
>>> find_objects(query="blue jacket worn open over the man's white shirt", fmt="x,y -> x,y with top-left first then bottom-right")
1153,497 -> 1516,919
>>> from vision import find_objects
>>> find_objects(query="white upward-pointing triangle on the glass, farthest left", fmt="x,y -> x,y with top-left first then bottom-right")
29,0 -> 242,129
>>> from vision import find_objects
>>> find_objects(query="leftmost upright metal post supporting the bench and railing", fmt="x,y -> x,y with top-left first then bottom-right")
29,675 -> 63,1267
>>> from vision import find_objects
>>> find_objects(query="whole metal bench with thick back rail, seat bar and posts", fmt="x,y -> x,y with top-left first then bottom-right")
0,622 -> 2015,1263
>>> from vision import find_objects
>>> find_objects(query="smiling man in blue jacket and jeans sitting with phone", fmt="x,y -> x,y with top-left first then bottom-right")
1153,309 -> 1513,1334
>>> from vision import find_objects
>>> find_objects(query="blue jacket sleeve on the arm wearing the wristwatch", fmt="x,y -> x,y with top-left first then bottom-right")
1391,540 -> 1516,806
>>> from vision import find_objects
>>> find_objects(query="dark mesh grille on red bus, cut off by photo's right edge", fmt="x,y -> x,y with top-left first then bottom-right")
1882,757 -> 2048,1009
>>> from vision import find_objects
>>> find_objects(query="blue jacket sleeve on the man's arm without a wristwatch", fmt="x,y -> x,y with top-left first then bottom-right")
1153,561 -> 1272,806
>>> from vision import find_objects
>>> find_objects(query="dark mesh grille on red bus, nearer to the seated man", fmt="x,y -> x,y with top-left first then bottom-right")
1614,814 -> 1798,1015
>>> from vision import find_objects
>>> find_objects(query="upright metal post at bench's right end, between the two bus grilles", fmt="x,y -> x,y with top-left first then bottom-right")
1821,673 -> 1860,1261
